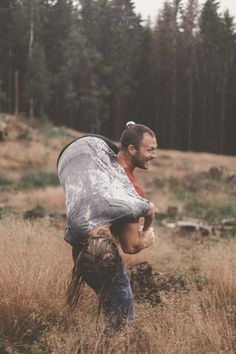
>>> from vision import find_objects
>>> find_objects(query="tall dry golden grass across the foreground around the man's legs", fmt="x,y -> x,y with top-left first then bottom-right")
0,218 -> 236,354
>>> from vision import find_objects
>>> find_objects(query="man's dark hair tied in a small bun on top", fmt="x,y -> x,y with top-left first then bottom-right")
120,121 -> 156,150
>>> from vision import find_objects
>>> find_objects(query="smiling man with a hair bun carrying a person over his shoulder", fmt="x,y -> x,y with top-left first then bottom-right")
99,122 -> 157,328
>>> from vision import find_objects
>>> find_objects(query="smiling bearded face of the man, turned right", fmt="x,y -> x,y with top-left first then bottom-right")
132,133 -> 157,170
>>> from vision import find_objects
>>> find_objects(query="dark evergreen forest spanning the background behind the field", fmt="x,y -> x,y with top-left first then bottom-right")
0,0 -> 236,154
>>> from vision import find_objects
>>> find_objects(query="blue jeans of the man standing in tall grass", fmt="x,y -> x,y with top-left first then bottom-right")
72,248 -> 134,332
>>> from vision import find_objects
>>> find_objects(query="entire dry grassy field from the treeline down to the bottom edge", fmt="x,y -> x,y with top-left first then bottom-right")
0,118 -> 236,354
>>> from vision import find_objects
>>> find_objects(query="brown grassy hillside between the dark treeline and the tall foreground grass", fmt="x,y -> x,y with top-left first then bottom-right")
0,117 -> 236,218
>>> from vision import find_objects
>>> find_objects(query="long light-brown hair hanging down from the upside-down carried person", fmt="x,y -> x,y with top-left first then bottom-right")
66,236 -> 121,312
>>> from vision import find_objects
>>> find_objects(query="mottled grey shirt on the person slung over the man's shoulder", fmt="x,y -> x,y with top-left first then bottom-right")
58,137 -> 150,245
